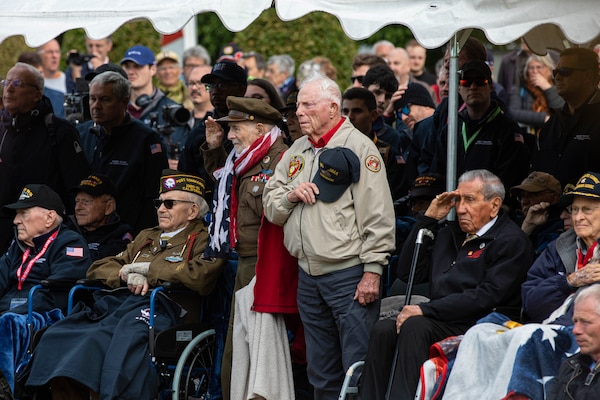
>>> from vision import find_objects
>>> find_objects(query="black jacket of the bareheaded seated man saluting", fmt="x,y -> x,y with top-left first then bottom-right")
398,213 -> 532,325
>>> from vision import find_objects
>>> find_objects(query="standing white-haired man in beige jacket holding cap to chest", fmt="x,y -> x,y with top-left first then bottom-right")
263,74 -> 394,399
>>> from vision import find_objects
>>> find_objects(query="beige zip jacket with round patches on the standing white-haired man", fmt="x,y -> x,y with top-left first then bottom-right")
263,118 -> 395,275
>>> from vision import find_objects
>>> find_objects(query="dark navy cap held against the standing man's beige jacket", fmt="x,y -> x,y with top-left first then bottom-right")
313,147 -> 360,203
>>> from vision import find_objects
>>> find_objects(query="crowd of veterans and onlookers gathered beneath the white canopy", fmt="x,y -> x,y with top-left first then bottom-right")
0,32 -> 600,400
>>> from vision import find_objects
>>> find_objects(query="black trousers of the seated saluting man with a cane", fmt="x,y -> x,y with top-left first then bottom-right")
360,316 -> 468,400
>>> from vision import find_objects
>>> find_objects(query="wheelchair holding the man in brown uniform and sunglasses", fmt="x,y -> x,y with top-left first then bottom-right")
21,259 -> 237,400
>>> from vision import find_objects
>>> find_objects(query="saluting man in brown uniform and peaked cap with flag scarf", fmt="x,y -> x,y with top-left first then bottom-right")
200,96 -> 287,399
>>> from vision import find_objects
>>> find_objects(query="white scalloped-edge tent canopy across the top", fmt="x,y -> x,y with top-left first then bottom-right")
0,0 -> 600,50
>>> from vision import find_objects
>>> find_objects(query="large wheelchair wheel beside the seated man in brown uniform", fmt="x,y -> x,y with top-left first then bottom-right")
173,329 -> 215,400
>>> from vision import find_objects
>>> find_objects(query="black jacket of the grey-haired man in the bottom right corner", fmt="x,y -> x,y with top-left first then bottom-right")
546,353 -> 600,400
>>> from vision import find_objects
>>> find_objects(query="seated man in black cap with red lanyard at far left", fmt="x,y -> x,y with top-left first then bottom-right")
0,184 -> 91,392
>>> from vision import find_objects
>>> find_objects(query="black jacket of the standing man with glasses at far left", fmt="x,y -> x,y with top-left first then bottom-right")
0,97 -> 90,254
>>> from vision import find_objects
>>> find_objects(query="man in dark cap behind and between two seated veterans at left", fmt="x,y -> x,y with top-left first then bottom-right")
67,174 -> 133,261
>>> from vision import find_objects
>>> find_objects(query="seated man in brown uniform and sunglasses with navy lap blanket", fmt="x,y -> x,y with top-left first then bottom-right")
27,170 -> 223,400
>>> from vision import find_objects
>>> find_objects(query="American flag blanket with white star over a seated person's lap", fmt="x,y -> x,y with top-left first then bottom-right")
443,313 -> 578,400
